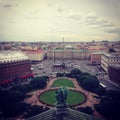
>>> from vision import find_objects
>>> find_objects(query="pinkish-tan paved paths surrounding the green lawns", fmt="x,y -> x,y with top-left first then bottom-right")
24,78 -> 102,118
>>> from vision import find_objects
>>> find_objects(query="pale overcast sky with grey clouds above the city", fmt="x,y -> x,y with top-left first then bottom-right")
0,0 -> 120,42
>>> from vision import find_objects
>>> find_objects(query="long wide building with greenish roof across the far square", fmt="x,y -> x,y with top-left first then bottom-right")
47,49 -> 90,60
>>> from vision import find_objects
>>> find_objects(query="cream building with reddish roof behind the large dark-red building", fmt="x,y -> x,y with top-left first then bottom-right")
23,50 -> 45,61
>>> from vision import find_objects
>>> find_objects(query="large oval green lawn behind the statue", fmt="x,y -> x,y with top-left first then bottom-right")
40,90 -> 86,106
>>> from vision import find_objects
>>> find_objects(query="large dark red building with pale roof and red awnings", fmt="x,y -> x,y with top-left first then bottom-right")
0,51 -> 33,85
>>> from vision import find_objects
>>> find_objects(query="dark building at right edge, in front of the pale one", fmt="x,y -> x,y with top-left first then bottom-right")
108,66 -> 120,86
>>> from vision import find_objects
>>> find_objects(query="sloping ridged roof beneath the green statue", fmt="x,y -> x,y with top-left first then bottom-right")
27,108 -> 102,120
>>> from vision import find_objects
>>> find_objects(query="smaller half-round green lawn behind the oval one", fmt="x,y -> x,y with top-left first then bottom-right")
52,78 -> 75,87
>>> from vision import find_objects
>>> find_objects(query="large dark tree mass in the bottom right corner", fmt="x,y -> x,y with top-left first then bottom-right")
94,90 -> 120,120
